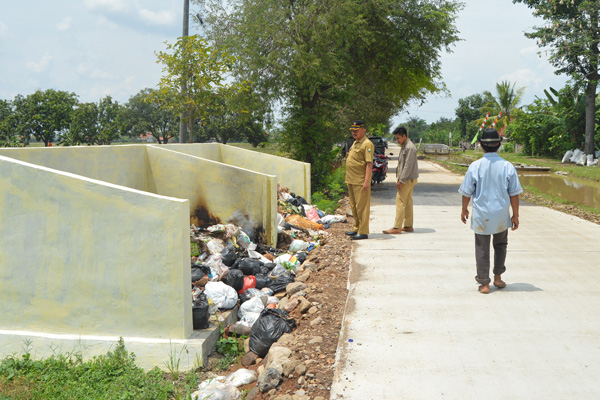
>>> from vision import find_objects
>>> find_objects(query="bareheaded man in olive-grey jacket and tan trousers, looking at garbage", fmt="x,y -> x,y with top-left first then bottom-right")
383,126 -> 419,235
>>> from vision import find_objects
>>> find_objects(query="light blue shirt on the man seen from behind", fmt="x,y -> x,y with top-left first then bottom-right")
458,153 -> 523,235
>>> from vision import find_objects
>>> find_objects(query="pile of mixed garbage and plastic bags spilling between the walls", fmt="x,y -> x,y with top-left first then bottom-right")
190,188 -> 345,357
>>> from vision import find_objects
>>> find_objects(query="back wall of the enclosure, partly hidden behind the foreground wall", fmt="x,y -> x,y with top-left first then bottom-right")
0,145 -> 151,191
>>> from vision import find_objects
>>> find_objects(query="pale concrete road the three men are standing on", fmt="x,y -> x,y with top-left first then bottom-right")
331,146 -> 600,400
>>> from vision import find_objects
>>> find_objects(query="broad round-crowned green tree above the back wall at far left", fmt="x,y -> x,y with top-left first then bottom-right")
15,89 -> 77,146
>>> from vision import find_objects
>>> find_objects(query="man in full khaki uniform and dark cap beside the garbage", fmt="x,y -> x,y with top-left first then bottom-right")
346,120 -> 375,240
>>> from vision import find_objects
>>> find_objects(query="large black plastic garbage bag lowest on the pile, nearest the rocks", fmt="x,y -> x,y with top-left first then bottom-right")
250,308 -> 296,358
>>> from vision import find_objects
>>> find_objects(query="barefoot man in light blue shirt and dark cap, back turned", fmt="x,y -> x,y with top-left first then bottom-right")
458,129 -> 523,294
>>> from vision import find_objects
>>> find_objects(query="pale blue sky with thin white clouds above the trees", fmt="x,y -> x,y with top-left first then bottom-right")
0,0 -> 567,124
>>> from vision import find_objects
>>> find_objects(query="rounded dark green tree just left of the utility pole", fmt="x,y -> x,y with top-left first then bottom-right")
117,88 -> 179,144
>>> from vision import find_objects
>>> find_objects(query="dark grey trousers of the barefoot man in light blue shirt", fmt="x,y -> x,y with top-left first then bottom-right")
475,229 -> 508,285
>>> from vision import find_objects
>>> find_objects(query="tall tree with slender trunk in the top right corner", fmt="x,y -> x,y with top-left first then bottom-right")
513,0 -> 600,154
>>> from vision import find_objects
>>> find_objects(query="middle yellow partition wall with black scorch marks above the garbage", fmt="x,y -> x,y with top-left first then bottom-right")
147,146 -> 277,245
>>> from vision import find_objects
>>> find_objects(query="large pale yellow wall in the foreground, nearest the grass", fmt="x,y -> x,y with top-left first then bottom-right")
0,155 -> 192,338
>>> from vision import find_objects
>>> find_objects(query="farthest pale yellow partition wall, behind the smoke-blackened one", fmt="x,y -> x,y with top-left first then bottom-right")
161,143 -> 311,203
